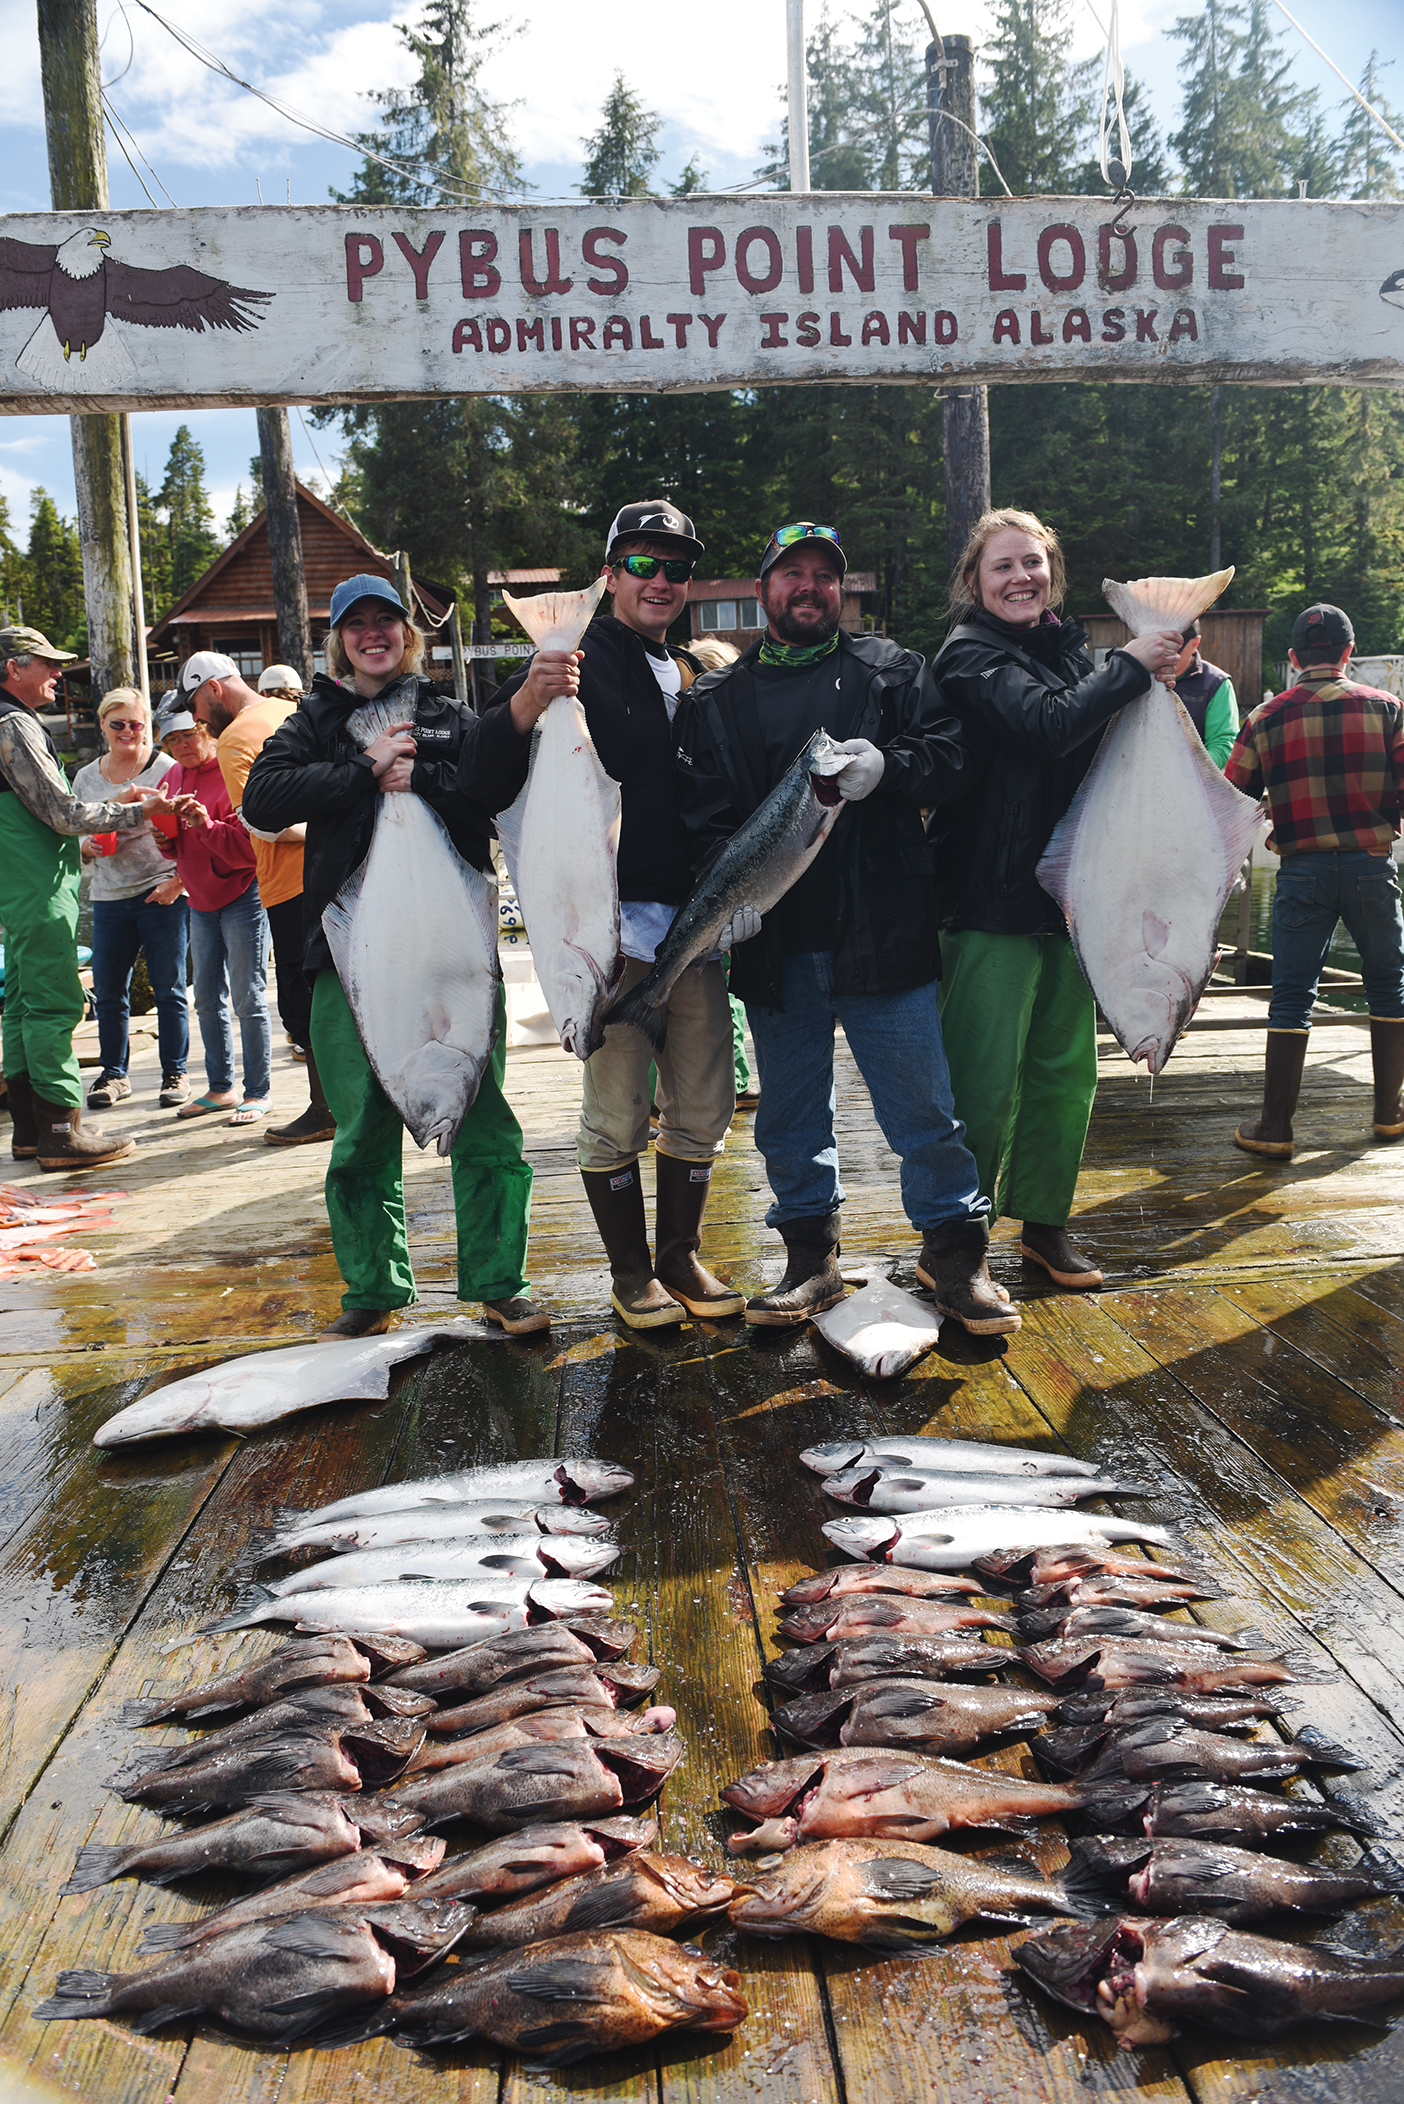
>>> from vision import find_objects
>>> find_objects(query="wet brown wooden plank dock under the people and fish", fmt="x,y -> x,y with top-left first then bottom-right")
0,995 -> 1404,2104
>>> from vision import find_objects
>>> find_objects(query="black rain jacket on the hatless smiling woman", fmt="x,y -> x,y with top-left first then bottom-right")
926,610 -> 1151,934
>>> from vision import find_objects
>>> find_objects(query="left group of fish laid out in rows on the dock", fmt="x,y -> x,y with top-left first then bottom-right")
38,1462 -> 745,2062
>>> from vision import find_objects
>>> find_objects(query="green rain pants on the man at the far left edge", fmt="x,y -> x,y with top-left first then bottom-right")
0,791 -> 86,1111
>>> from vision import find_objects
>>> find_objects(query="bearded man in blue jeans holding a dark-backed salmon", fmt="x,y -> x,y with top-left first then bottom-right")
678,520 -> 1019,1336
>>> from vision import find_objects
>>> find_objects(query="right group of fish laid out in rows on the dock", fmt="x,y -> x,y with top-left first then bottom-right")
720,1437 -> 1404,2045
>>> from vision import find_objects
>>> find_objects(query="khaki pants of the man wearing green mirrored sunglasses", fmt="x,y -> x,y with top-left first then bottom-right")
577,957 -> 737,1170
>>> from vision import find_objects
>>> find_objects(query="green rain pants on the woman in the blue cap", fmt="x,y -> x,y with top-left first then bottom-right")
312,968 -> 530,1309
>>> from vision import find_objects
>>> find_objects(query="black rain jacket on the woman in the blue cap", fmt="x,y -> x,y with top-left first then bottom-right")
244,673 -> 493,978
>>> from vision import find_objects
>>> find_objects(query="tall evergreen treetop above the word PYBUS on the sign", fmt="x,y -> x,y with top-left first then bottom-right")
333,0 -> 522,204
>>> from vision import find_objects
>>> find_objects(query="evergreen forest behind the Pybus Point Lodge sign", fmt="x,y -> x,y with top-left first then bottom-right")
0,0 -> 1404,663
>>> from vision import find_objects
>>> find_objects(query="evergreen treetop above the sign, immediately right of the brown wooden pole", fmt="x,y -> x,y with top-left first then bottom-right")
981,0 -> 1097,196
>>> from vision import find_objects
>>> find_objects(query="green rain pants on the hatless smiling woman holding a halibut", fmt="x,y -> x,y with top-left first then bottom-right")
941,928 -> 1097,1227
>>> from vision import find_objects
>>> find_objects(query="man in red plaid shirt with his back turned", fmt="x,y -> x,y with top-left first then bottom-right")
1223,606 -> 1404,1159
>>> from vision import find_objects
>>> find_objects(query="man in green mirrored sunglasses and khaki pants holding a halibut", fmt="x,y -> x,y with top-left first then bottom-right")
459,499 -> 745,1330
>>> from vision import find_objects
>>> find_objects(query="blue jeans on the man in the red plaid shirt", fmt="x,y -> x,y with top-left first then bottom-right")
1267,850 -> 1404,1031
